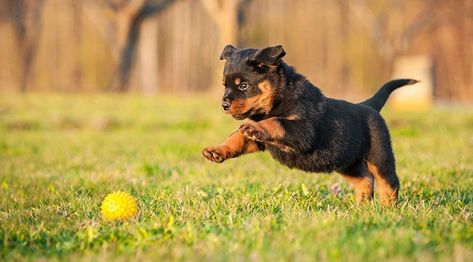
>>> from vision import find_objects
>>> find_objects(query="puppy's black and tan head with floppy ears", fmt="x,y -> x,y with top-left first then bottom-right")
220,45 -> 286,120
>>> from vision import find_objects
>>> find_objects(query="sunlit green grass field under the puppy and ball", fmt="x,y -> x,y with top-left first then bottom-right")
0,95 -> 473,261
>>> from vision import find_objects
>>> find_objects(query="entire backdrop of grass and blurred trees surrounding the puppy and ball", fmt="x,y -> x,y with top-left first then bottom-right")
0,0 -> 473,262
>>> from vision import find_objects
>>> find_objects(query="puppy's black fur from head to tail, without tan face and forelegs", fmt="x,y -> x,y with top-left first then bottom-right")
204,45 -> 417,205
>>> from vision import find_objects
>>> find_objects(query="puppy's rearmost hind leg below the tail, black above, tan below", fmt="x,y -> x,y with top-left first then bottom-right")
366,116 -> 399,206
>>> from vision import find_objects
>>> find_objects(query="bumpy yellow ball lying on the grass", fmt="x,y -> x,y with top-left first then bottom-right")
100,191 -> 138,221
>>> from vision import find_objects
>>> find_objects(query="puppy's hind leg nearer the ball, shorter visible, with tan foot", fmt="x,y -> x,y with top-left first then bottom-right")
340,162 -> 373,204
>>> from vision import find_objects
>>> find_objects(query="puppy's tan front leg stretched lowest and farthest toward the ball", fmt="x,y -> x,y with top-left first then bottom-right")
202,130 -> 264,163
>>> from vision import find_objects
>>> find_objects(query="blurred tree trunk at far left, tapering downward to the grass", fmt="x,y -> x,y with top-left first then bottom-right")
4,0 -> 44,91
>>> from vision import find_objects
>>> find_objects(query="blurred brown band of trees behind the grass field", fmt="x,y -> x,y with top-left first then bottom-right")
0,0 -> 473,103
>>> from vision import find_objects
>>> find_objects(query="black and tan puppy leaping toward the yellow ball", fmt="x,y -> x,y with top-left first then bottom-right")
203,45 -> 417,205
